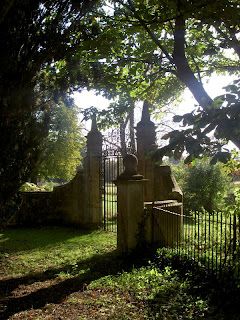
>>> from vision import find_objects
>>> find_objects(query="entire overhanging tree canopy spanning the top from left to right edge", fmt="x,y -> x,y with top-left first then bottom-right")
0,0 -> 240,222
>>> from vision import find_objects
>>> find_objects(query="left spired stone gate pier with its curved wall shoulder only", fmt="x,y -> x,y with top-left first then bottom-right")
50,117 -> 102,229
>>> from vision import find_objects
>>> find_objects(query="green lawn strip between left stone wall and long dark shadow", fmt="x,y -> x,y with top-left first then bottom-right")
0,228 -> 116,277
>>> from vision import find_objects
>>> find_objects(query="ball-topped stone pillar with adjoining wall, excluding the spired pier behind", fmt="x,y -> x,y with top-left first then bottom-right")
115,155 -> 183,254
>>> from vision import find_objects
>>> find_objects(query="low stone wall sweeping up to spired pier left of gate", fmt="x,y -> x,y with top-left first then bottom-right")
15,118 -> 102,228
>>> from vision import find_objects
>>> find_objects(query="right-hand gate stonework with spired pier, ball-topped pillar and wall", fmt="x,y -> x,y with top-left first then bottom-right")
115,102 -> 183,254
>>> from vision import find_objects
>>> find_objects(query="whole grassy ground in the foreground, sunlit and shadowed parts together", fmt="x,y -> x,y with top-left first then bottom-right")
0,228 -> 240,320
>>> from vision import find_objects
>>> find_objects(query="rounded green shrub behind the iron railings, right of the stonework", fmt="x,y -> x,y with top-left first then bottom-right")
173,158 -> 231,213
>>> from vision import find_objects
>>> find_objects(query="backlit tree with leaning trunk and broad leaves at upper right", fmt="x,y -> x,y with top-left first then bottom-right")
75,0 -> 240,157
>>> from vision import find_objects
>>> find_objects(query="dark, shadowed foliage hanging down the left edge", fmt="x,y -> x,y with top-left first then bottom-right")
0,0 -> 99,220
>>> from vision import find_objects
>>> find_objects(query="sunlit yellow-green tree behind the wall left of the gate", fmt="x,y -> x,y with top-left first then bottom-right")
31,102 -> 85,182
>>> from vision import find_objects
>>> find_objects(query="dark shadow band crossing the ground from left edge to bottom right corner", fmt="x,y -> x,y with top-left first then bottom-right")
0,250 -> 240,320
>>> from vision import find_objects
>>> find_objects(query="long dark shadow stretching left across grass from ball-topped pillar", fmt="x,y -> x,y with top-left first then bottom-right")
0,251 -> 148,319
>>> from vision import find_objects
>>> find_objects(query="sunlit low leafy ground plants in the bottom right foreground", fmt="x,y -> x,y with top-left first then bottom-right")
90,264 -> 208,319
